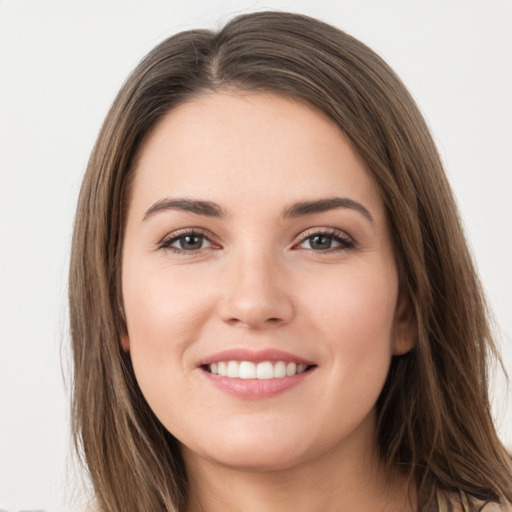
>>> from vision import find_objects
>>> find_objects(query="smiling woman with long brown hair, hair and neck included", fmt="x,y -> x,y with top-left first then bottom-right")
70,12 -> 512,512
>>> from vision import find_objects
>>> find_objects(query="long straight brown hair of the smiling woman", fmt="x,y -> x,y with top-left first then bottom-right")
69,12 -> 512,512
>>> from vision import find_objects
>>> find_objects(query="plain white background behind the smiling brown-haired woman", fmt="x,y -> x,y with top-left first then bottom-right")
0,0 -> 512,511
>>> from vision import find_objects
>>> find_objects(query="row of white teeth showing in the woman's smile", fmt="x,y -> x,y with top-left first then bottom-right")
208,361 -> 307,380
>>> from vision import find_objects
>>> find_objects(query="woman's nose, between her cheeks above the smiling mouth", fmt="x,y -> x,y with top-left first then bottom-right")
219,250 -> 294,329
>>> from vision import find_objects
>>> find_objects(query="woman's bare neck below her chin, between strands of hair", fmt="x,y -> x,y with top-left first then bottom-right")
184,418 -> 415,512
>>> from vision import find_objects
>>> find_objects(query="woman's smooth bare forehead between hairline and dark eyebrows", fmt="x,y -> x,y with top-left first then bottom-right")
128,92 -> 383,222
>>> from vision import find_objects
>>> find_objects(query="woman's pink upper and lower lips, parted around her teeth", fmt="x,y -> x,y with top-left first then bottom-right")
197,348 -> 316,400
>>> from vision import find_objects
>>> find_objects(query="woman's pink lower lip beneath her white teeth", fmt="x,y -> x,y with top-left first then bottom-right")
200,368 -> 315,400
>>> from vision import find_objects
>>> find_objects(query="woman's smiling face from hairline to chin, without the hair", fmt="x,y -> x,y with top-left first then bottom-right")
122,92 -> 411,469
